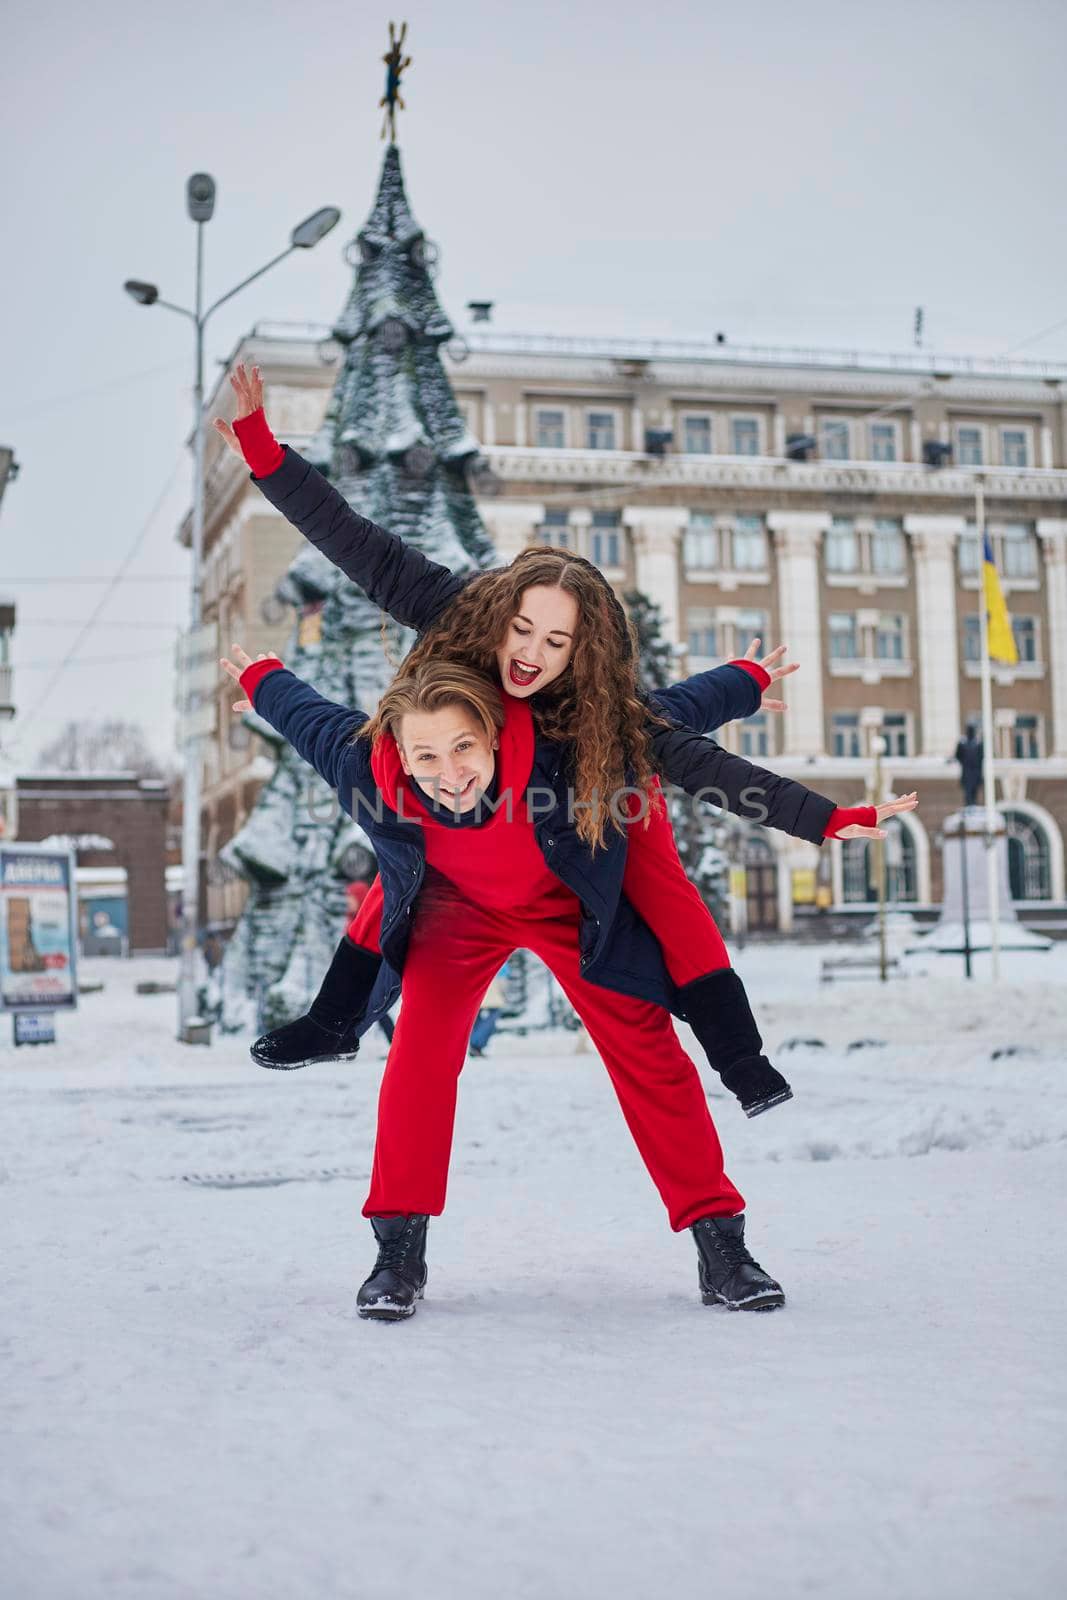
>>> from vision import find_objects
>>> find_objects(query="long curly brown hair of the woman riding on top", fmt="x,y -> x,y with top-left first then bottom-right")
383,547 -> 665,848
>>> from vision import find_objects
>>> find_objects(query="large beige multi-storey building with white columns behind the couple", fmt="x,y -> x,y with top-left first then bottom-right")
191,325 -> 1067,930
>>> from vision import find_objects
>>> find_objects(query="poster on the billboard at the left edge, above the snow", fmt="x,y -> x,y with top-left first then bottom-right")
0,843 -> 78,1011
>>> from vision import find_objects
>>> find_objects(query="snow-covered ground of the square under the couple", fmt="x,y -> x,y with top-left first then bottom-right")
0,946 -> 1067,1600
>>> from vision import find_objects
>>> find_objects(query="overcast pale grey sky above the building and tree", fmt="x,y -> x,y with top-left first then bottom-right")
0,0 -> 1067,768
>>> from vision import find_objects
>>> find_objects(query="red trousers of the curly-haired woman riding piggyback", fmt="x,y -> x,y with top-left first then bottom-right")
349,780 -> 729,986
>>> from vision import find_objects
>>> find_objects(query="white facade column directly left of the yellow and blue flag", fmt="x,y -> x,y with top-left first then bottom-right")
904,517 -> 966,757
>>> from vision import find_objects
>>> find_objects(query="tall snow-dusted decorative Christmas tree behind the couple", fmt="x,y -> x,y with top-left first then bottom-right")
221,140 -> 496,1030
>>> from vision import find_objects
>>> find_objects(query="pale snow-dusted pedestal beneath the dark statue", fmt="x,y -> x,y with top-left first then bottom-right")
910,805 -> 1053,955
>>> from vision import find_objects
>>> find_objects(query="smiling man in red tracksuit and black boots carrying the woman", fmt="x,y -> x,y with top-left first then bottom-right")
224,651 -> 784,1320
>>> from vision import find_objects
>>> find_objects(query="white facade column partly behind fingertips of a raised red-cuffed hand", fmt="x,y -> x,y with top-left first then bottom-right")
766,510 -> 830,755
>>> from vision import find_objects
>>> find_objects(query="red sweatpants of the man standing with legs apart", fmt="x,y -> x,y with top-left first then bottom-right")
363,875 -> 744,1230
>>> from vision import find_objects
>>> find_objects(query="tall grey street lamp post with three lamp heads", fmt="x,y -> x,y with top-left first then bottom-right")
123,173 -> 341,1043
